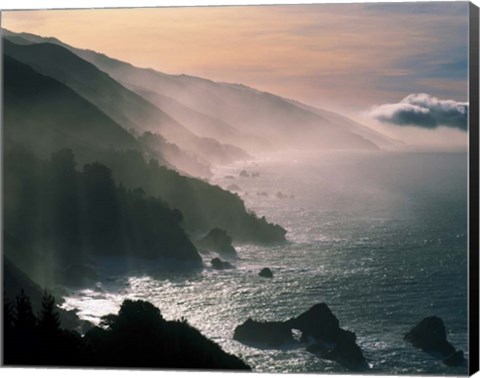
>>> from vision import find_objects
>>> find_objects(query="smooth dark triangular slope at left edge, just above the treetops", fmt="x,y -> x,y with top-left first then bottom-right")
3,53 -> 140,159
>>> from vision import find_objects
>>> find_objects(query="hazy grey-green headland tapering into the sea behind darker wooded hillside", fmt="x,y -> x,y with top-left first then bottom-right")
80,151 -> 286,243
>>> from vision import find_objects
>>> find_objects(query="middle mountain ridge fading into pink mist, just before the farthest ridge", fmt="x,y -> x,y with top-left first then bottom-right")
3,36 -> 249,175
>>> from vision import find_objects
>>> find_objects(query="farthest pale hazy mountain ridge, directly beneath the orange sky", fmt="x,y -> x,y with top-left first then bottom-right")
3,28 -> 395,151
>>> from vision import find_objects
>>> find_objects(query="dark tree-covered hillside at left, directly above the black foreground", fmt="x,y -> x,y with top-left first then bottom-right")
3,147 -> 202,286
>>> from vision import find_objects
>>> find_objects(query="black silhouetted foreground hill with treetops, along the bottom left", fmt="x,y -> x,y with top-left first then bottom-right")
3,292 -> 250,370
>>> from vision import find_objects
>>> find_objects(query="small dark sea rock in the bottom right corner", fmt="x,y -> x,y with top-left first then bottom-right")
404,316 -> 463,366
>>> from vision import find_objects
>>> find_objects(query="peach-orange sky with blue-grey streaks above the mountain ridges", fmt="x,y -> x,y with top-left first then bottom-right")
2,2 -> 468,146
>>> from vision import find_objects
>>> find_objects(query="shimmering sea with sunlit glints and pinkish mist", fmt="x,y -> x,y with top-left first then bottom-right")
64,152 -> 468,374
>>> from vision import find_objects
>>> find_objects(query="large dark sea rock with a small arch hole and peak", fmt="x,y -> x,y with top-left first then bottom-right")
233,303 -> 367,369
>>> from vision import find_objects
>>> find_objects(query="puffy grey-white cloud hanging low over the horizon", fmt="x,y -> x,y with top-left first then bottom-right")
369,93 -> 468,131
